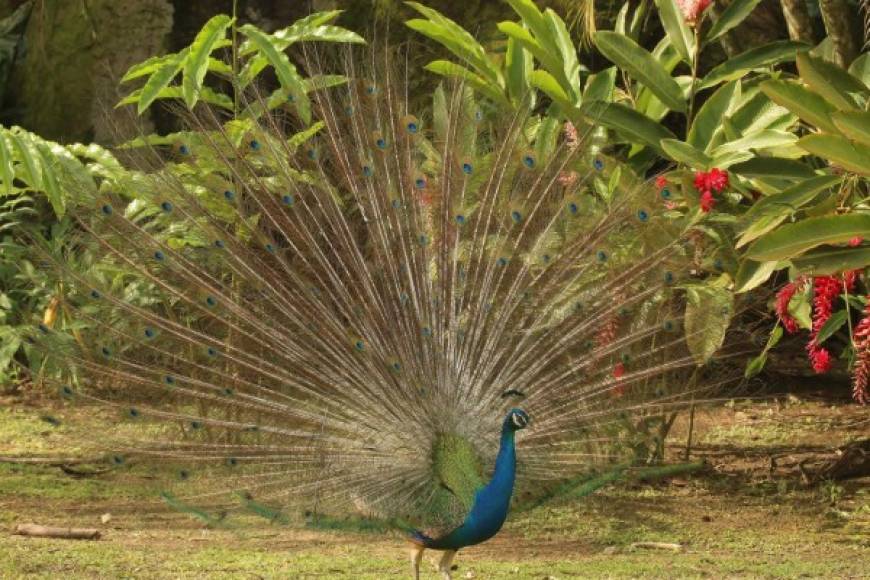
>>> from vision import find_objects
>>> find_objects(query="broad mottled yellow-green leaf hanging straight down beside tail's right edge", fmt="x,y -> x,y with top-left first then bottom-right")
684,285 -> 734,365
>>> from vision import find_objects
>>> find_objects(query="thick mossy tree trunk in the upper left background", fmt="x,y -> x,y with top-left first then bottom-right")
10,0 -> 172,143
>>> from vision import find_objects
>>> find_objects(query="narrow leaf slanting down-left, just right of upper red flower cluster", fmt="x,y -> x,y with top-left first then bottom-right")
736,175 -> 843,248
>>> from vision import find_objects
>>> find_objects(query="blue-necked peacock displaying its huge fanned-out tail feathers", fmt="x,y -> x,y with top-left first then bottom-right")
32,47 -> 748,563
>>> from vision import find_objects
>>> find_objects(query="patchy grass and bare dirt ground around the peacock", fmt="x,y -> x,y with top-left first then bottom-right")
0,397 -> 870,579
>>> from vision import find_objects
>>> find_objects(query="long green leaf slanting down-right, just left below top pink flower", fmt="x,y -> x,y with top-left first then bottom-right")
594,30 -> 686,113
